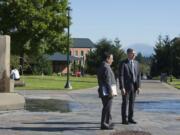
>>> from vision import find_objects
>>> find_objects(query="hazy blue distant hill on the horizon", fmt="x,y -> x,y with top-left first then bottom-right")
123,43 -> 154,56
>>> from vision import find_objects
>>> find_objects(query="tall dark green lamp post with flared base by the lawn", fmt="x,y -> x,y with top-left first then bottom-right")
64,6 -> 72,89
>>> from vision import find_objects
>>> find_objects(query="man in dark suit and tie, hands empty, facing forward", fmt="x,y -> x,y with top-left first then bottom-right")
119,48 -> 141,124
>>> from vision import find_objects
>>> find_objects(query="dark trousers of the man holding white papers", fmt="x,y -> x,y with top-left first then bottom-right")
101,96 -> 112,127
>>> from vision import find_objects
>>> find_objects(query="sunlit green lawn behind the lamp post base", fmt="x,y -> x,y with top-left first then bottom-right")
15,75 -> 97,90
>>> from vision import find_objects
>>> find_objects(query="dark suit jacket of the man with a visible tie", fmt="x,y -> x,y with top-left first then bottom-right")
119,59 -> 141,92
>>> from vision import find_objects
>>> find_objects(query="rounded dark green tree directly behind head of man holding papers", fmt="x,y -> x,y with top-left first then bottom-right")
86,39 -> 125,76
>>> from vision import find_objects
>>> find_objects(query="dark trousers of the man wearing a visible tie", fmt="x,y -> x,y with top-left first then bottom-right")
121,88 -> 136,121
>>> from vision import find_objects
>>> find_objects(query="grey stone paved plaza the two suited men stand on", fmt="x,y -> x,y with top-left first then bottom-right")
0,80 -> 180,135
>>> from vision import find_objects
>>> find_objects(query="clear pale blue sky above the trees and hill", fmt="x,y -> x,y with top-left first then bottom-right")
69,0 -> 180,47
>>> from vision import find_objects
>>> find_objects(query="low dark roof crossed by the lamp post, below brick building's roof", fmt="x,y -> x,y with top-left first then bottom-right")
47,53 -> 81,61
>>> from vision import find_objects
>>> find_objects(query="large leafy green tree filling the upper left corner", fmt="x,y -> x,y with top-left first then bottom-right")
0,0 -> 68,71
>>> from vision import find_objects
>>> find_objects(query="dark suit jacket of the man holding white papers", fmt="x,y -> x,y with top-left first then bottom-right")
97,62 -> 116,97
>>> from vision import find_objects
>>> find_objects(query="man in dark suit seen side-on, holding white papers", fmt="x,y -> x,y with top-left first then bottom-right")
97,53 -> 116,130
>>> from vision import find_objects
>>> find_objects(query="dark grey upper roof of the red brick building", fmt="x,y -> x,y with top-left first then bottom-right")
71,38 -> 95,48
